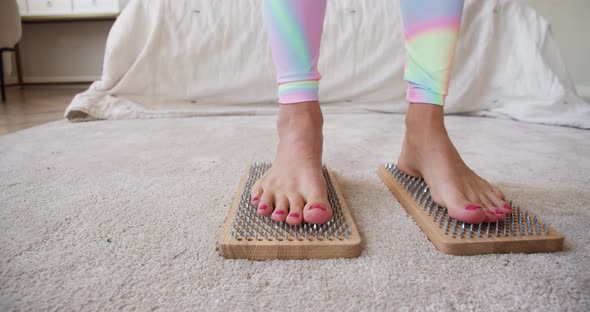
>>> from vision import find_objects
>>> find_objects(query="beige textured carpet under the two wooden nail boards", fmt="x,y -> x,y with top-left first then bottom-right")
0,114 -> 590,311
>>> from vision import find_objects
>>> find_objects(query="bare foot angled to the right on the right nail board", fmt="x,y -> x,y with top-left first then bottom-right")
397,103 -> 512,224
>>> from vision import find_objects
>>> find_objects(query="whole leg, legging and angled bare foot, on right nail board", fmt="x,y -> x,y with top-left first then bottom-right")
398,0 -> 511,223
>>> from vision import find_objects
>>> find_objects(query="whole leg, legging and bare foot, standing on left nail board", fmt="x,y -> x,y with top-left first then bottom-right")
251,0 -> 333,225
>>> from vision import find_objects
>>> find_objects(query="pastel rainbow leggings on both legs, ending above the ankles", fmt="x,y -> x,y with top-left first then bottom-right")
264,0 -> 463,105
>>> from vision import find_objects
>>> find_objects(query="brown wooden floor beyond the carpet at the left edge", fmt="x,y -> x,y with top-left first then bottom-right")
0,84 -> 89,135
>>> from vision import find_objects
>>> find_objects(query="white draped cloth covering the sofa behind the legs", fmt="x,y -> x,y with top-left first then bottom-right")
65,0 -> 590,129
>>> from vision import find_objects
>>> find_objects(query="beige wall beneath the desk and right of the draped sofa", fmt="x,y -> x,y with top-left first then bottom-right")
9,0 -> 590,96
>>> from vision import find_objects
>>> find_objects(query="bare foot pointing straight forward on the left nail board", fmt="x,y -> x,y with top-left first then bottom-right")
251,102 -> 333,225
